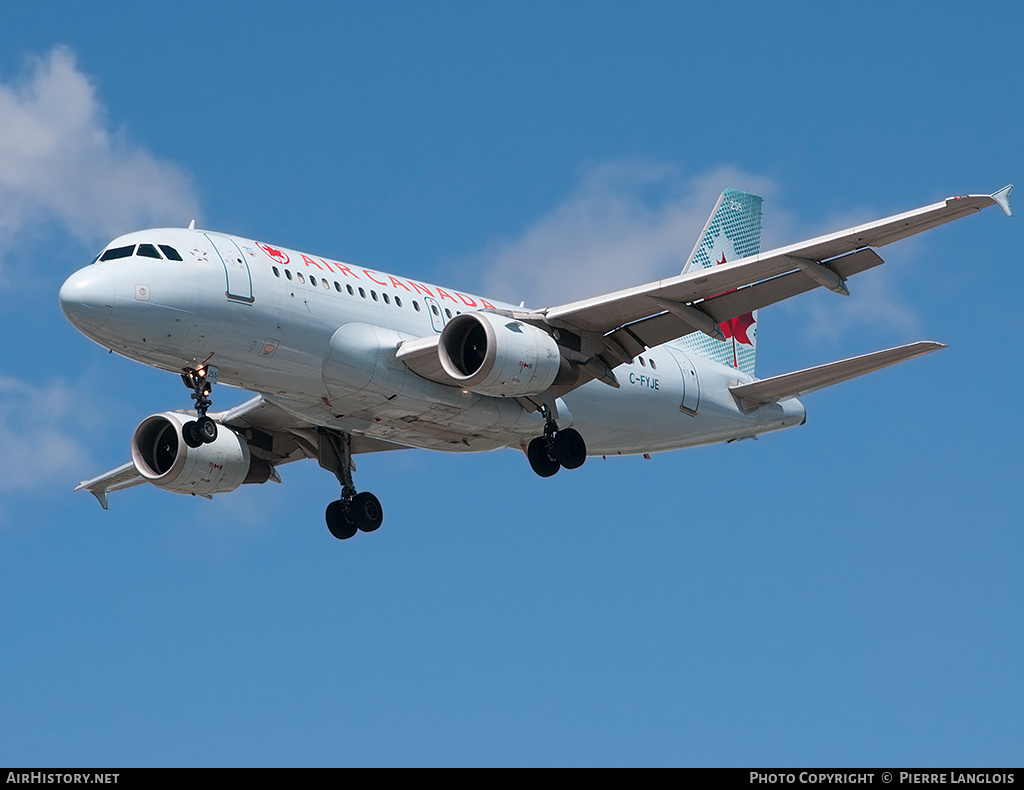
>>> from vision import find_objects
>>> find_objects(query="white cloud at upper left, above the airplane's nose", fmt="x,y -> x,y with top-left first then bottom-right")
0,47 -> 198,272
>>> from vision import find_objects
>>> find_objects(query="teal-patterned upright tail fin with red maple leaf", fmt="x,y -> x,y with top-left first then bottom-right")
676,190 -> 761,376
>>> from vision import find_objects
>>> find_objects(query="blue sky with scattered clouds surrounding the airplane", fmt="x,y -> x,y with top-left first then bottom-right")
0,0 -> 1024,766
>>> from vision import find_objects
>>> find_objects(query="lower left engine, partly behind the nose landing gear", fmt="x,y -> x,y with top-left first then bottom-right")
131,412 -> 271,496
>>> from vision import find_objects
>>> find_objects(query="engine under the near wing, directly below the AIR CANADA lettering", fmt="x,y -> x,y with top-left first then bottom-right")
437,313 -> 561,398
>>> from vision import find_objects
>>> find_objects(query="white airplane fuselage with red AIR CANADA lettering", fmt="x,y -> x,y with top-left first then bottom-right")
60,228 -> 804,455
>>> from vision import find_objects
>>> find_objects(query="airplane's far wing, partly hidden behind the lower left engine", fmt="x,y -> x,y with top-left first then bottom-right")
75,396 -> 404,510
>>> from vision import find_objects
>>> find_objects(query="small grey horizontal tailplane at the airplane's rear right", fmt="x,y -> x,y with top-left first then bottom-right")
729,341 -> 946,406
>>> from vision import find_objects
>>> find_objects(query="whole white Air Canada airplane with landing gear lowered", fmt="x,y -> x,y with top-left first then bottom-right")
59,185 -> 1012,540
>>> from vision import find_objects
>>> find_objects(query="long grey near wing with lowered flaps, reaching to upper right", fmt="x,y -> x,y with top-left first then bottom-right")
508,186 -> 1012,394
